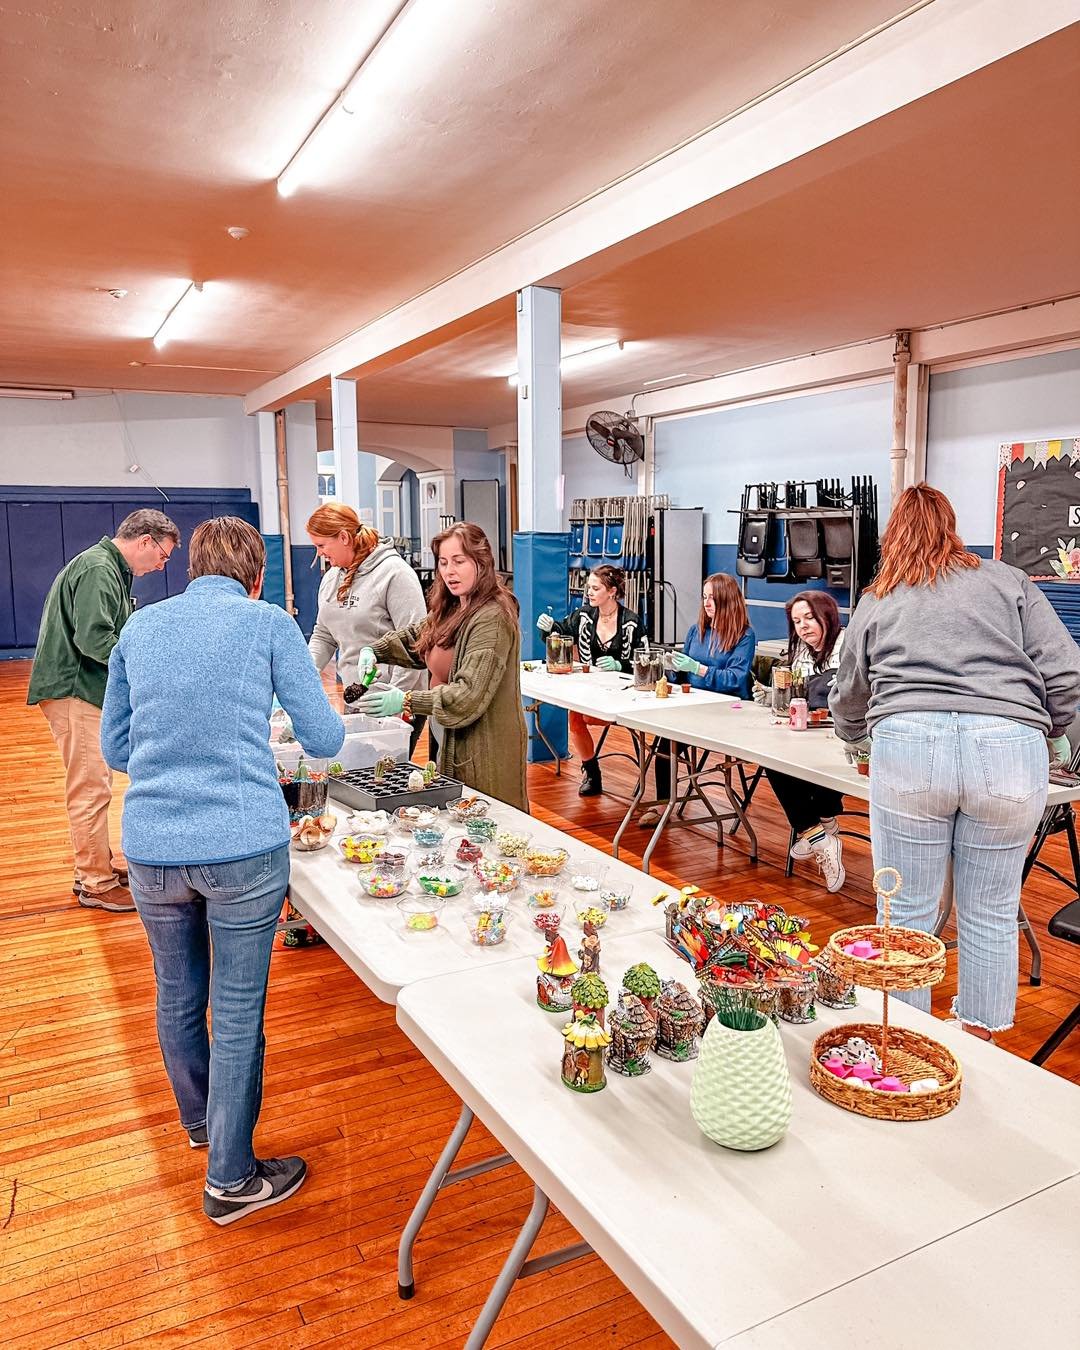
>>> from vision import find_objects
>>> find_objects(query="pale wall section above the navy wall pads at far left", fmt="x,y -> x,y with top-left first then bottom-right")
0,392 -> 258,487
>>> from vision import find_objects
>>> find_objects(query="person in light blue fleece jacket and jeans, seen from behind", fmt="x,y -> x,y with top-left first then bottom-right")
101,516 -> 344,1224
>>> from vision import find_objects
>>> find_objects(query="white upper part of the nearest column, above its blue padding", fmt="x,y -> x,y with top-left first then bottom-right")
517,286 -> 563,531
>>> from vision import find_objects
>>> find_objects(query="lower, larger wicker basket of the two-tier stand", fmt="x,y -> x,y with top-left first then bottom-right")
810,1022 -> 961,1121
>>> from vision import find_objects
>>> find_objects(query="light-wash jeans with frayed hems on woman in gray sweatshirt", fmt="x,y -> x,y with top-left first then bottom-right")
869,713 -> 1049,1031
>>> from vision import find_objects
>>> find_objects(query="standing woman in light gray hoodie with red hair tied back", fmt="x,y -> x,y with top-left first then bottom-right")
308,502 -> 428,747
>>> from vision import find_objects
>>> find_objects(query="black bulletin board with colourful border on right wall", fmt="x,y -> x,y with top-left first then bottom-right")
994,437 -> 1080,582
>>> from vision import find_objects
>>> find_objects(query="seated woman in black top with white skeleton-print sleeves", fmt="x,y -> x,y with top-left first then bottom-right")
536,563 -> 644,797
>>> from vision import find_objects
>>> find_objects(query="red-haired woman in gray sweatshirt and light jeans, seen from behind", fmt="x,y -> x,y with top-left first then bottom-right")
829,483 -> 1080,1040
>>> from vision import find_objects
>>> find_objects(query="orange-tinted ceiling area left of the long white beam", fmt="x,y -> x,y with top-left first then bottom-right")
0,0 -> 918,396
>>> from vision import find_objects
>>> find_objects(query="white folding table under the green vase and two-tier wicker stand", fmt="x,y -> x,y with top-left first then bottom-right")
397,932 -> 1080,1350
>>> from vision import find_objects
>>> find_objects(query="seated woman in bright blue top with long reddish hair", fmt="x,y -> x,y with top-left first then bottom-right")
641,572 -> 757,825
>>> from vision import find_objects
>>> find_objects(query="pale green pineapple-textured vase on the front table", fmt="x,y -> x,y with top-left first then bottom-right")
690,1018 -> 791,1152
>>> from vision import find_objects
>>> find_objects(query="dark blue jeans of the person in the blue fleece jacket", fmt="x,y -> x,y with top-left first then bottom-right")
128,845 -> 289,1188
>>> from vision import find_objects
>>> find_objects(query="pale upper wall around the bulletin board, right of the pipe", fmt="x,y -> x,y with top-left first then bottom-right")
926,348 -> 1080,545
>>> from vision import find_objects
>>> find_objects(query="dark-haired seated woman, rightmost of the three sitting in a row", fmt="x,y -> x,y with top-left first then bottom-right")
765,591 -> 846,891
